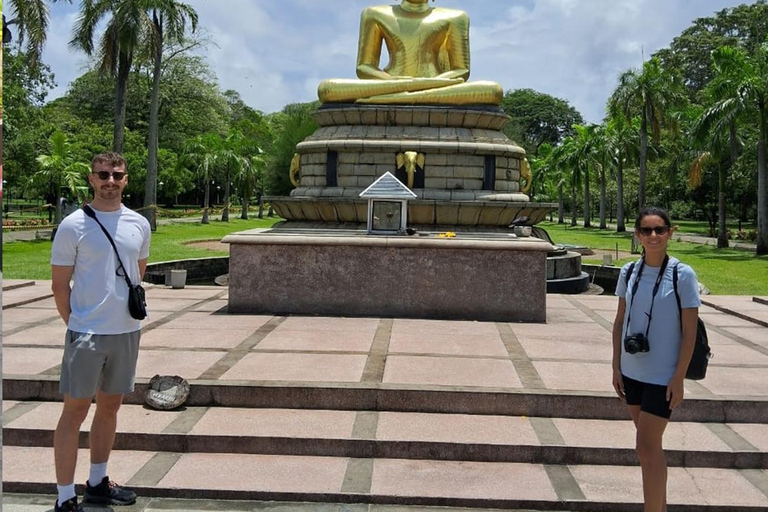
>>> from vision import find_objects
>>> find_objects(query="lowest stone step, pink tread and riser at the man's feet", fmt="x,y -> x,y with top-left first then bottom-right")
3,446 -> 768,512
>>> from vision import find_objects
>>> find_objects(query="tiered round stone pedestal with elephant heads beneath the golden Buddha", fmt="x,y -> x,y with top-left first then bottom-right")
270,104 -> 556,226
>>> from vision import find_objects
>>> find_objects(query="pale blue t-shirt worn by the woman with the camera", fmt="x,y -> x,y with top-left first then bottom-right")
616,256 -> 701,386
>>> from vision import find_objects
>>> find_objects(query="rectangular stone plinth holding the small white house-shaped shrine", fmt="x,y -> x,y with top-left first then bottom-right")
224,229 -> 552,322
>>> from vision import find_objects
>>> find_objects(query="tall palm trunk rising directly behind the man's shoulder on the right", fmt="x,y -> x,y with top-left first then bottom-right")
142,11 -> 163,231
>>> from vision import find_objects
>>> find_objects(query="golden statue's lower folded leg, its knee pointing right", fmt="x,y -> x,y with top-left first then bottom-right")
357,82 -> 504,105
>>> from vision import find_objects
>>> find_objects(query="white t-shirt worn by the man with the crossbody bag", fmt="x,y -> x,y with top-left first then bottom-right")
51,205 -> 151,334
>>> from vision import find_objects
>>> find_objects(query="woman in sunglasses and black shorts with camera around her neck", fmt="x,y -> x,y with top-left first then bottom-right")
613,207 -> 701,512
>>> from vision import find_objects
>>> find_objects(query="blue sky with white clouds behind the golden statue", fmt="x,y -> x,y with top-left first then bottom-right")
34,0 -> 743,122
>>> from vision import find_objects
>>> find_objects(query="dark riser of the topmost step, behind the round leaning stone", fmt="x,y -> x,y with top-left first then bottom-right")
3,375 -> 768,423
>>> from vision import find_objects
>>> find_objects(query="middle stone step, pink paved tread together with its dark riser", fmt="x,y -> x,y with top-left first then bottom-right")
3,401 -> 768,469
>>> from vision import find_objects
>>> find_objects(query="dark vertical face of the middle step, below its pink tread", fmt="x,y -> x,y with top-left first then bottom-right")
3,427 -> 768,469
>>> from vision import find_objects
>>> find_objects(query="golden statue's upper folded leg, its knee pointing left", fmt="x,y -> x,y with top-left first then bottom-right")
317,78 -> 461,103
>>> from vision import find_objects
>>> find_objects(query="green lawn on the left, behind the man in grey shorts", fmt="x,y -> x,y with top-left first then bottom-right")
3,217 -> 282,279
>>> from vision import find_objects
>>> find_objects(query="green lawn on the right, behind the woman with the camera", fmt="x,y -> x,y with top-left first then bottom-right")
539,222 -> 768,295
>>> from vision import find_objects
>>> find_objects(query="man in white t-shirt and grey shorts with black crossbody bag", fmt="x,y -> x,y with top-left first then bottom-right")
51,153 -> 150,512
